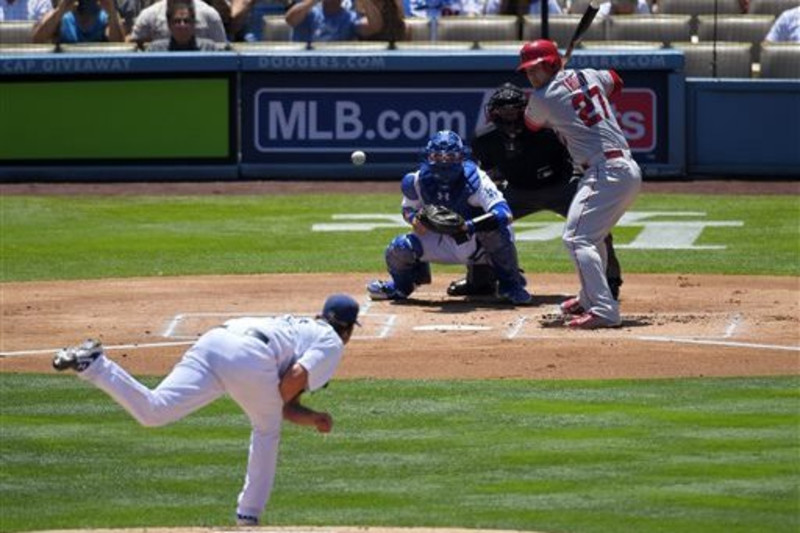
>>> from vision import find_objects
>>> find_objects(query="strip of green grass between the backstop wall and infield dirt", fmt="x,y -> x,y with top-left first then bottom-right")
0,194 -> 800,281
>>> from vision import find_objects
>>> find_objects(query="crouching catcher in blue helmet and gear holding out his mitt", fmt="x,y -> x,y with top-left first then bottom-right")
367,130 -> 532,305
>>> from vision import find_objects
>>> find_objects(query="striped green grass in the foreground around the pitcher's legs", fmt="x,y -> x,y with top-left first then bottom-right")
0,374 -> 800,533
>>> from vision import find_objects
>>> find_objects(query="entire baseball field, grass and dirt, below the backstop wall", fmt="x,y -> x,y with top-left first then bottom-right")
0,181 -> 800,533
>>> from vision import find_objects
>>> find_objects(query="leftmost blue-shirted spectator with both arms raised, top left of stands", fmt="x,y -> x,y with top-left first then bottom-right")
37,0 -> 125,44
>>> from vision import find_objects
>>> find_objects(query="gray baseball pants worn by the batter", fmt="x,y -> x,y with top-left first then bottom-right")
563,157 -> 642,323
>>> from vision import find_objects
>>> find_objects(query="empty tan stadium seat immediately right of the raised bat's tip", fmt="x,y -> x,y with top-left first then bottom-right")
606,15 -> 692,43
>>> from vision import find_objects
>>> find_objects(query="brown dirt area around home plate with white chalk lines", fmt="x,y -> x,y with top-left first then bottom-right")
0,273 -> 800,379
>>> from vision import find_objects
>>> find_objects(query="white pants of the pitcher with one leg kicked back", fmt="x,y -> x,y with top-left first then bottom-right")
78,328 -> 283,517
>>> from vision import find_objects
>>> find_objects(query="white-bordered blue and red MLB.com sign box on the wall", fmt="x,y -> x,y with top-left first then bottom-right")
253,87 -> 658,153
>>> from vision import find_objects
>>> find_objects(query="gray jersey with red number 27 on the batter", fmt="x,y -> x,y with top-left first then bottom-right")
525,69 -> 629,166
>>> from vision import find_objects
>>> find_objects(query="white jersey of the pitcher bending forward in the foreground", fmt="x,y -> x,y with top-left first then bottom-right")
225,315 -> 344,391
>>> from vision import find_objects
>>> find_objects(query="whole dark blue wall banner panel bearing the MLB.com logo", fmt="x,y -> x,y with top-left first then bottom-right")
242,63 -> 669,174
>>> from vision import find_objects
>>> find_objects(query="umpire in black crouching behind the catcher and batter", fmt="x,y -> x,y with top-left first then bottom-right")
447,83 -> 622,300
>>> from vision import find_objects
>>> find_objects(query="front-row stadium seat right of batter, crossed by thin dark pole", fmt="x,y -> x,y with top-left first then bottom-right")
672,42 -> 752,78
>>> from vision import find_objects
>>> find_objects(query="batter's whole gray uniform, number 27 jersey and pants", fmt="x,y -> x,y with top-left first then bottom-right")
525,69 -> 642,324
